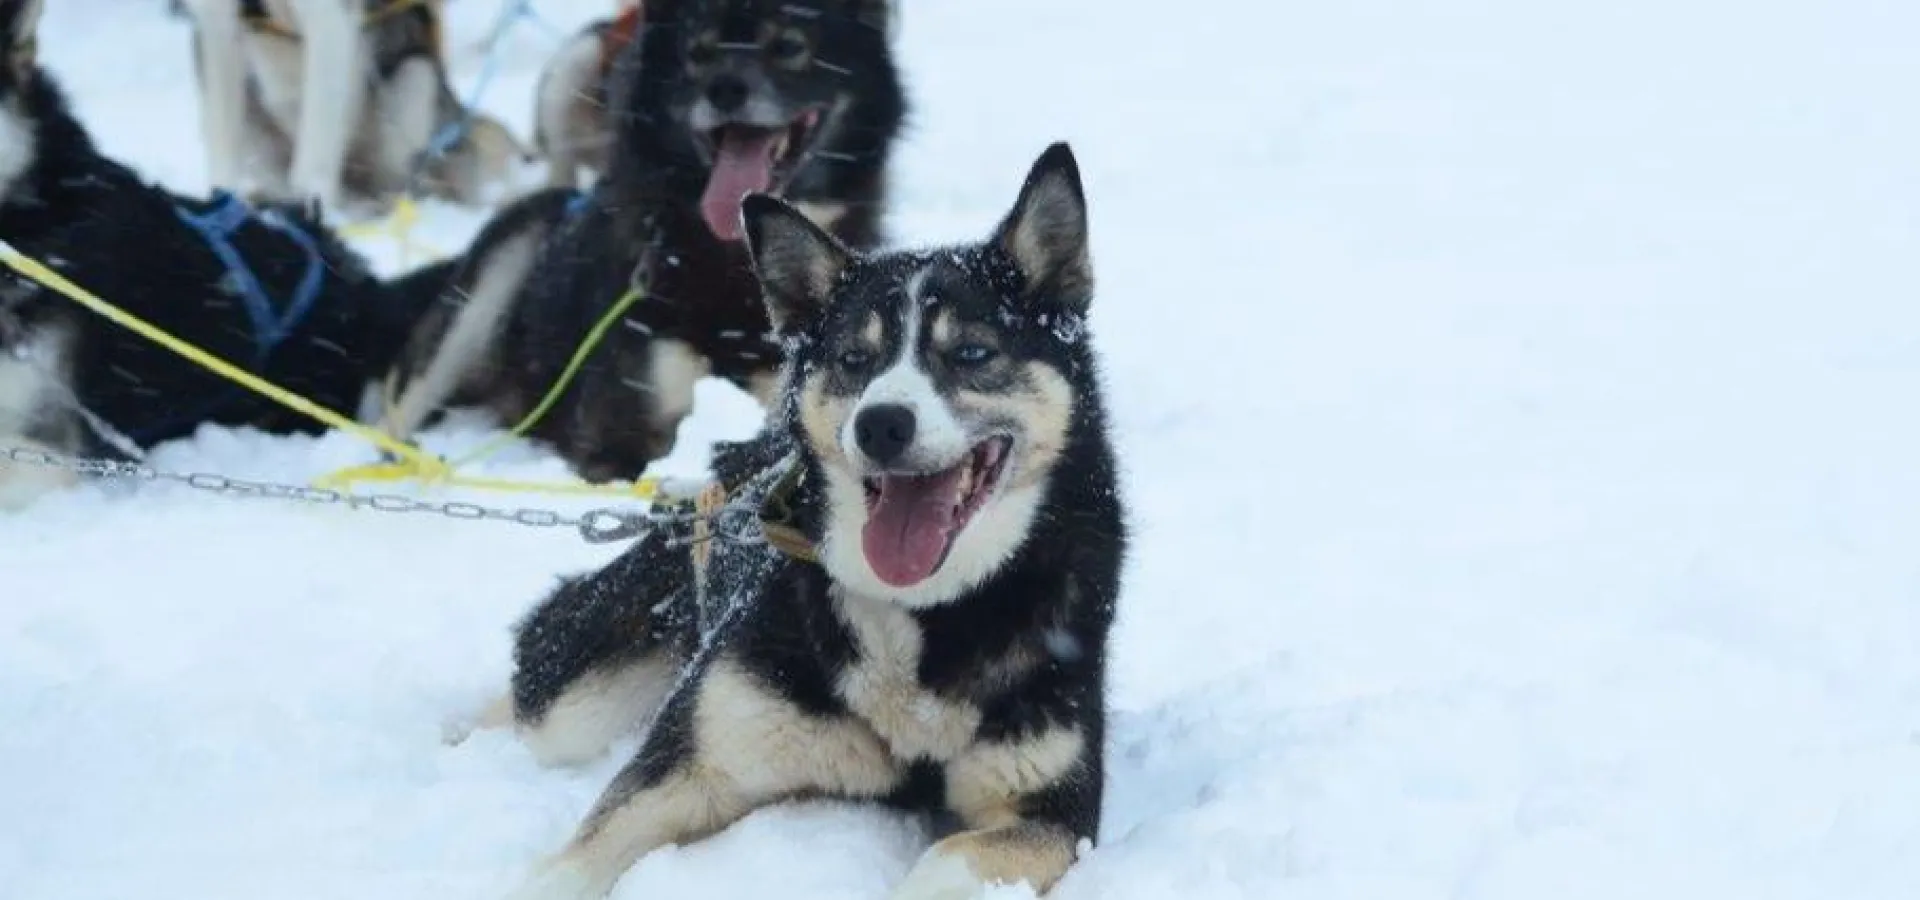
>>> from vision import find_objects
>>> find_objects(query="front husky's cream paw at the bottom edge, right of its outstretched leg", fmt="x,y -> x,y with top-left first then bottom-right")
893,821 -> 1077,900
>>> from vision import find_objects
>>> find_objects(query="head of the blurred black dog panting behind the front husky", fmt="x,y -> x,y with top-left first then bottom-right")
611,0 -> 904,242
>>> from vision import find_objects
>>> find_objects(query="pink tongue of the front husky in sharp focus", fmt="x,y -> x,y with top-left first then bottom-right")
860,464 -> 966,587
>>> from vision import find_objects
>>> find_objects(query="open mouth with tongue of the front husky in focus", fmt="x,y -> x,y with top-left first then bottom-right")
860,436 -> 1014,587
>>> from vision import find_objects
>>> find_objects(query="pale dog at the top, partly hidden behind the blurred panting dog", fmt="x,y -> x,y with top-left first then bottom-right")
534,2 -> 641,188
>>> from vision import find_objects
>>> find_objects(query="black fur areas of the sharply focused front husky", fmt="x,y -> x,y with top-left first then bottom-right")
513,146 -> 1127,888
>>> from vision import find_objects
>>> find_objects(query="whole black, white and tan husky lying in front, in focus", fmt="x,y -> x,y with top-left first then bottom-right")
476,144 -> 1125,900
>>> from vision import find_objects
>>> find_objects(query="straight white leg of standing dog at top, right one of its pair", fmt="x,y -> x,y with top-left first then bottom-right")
290,0 -> 367,207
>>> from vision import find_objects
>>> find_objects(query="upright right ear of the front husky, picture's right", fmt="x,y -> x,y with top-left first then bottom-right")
993,144 -> 1092,309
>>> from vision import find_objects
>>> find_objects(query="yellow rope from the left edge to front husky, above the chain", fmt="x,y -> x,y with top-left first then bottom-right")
0,240 -> 659,499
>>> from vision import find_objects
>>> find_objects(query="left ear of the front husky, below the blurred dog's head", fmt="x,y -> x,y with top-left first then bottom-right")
739,194 -> 852,332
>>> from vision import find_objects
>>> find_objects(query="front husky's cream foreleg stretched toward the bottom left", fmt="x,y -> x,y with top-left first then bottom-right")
513,658 -> 900,900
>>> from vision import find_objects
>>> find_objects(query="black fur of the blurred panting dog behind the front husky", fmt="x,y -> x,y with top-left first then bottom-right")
387,0 -> 906,480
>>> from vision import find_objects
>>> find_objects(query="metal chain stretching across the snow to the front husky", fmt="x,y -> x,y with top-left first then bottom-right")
0,447 -> 660,543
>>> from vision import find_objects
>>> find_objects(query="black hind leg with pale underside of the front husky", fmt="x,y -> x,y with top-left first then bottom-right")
513,532 -> 693,766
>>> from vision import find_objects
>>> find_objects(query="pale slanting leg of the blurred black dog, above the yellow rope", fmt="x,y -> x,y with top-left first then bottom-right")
382,228 -> 547,441
